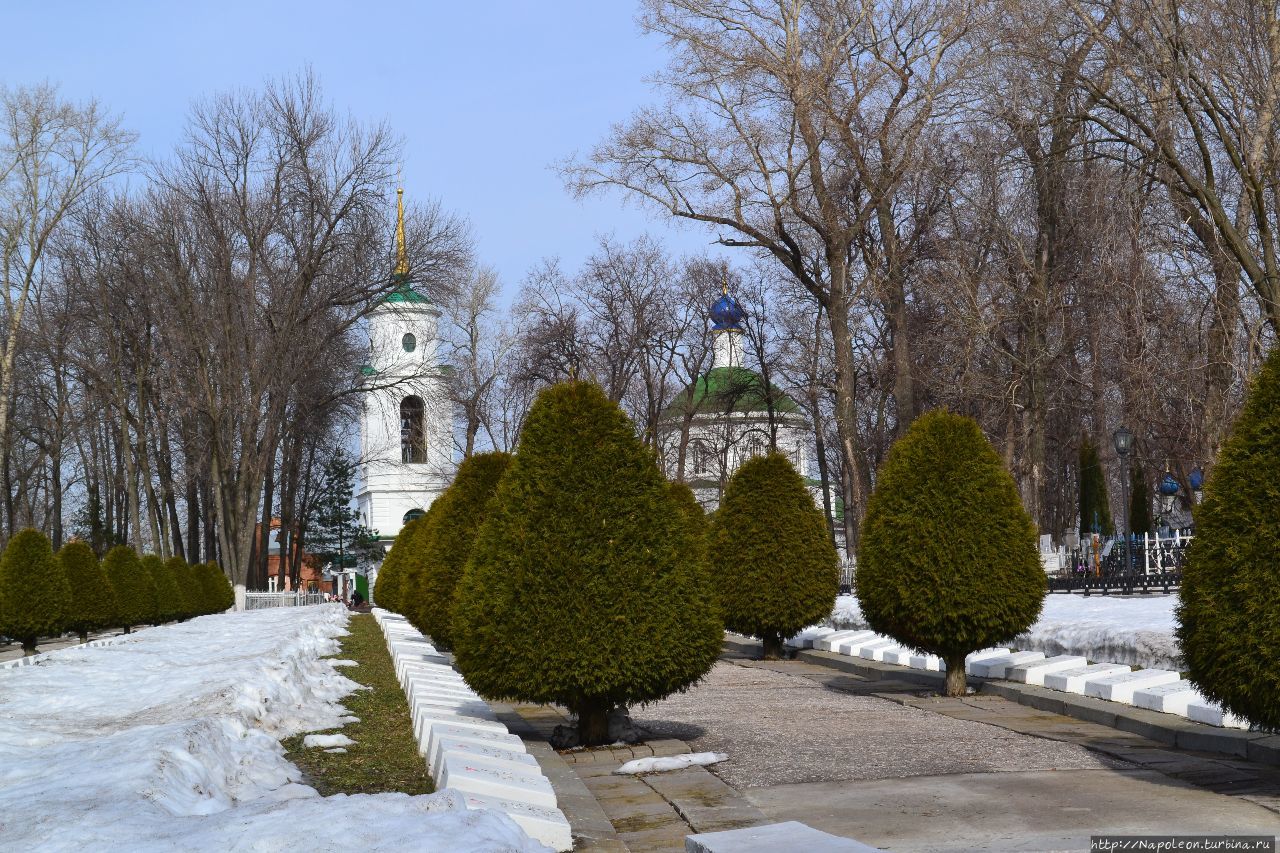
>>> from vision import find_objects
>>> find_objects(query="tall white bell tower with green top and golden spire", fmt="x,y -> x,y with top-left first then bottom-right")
356,188 -> 453,540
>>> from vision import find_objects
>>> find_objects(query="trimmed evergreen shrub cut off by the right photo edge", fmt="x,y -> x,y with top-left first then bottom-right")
1176,347 -> 1280,729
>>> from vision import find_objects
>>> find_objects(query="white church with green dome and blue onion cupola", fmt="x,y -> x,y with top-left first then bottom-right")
658,287 -> 809,511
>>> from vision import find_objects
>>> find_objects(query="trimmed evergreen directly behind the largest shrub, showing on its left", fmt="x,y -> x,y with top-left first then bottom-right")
401,451 -> 512,649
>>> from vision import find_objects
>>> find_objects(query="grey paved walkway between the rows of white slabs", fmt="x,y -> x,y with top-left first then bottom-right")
508,640 -> 1280,852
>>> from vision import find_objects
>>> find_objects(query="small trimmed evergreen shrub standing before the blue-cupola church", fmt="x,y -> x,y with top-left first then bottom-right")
708,453 -> 840,658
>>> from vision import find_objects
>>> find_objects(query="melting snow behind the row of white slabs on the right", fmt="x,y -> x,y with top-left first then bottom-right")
831,594 -> 1187,671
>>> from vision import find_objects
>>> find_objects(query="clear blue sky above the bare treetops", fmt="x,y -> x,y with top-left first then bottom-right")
0,0 -> 732,303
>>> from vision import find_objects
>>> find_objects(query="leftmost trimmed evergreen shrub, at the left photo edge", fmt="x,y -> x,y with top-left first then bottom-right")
0,528 -> 70,654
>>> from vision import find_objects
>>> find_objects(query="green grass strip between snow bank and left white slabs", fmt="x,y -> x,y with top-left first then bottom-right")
284,615 -> 435,797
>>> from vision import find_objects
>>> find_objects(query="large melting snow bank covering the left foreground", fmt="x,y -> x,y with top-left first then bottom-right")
0,605 -> 544,853
